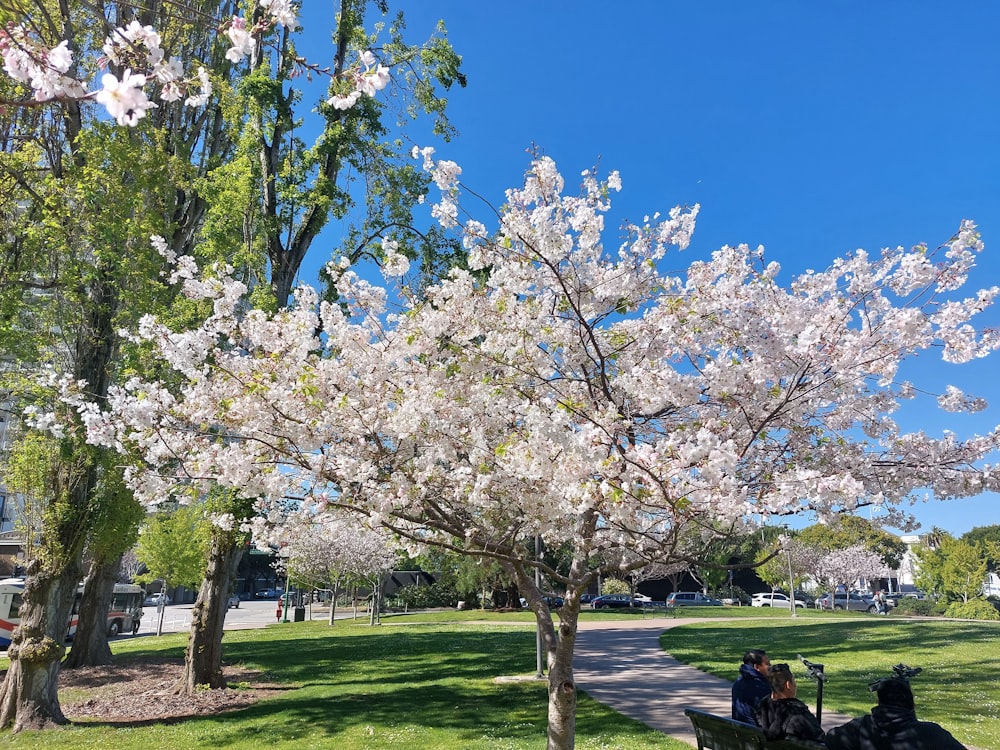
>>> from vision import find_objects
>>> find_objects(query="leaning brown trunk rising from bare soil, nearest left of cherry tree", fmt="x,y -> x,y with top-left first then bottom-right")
174,537 -> 243,695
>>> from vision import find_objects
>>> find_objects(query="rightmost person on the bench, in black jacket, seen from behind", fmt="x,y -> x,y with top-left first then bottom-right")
826,677 -> 966,750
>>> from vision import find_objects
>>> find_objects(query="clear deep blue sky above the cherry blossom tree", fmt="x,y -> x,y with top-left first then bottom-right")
306,0 -> 1000,533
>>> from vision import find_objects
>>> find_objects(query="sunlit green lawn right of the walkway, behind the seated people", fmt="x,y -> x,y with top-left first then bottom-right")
660,610 -> 1000,749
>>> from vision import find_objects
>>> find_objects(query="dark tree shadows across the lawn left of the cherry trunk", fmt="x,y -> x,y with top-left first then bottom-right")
104,625 -> 662,747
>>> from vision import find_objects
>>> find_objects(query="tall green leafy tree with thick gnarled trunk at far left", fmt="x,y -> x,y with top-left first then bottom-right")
0,0 -> 240,729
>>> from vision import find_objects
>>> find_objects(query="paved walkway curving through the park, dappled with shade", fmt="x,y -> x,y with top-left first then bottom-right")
573,617 -> 851,746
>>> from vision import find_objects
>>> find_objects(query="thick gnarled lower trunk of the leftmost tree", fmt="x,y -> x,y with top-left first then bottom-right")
0,558 -> 81,732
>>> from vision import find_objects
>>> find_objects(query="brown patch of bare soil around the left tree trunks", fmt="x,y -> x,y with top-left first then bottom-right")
59,659 -> 280,724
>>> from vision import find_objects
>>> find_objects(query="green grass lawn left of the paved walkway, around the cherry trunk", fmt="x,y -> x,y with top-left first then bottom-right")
0,612 -> 687,750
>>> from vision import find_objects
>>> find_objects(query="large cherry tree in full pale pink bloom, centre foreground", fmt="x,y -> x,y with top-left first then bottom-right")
65,150 -> 998,748
